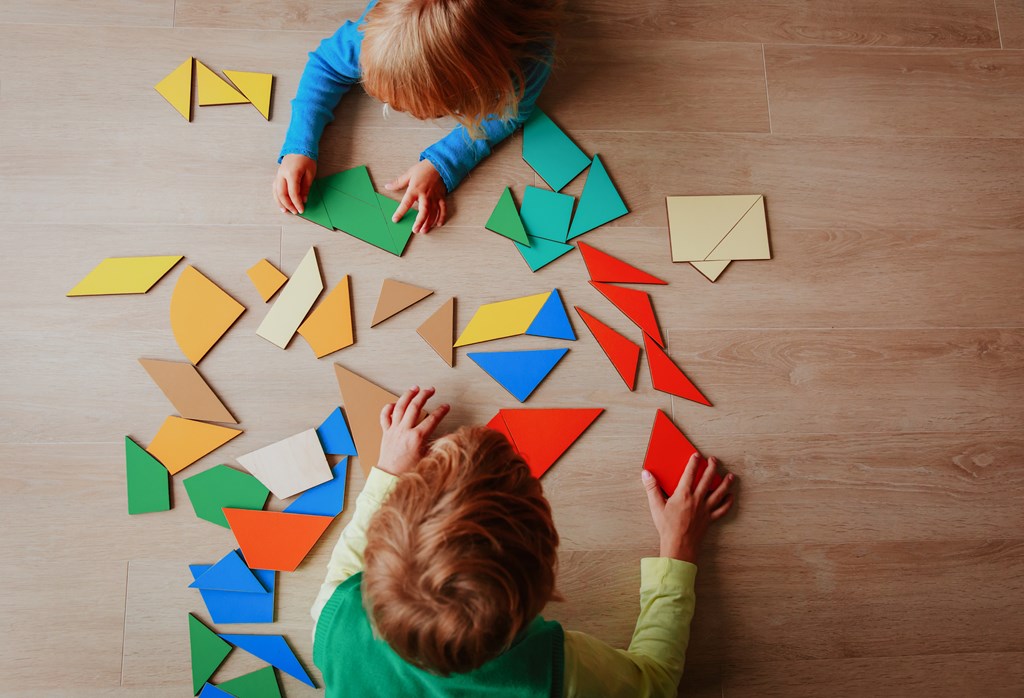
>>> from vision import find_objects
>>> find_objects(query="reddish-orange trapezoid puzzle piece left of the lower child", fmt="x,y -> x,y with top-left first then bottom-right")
224,509 -> 334,572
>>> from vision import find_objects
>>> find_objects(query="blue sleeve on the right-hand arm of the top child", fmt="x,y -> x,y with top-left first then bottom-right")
420,54 -> 551,191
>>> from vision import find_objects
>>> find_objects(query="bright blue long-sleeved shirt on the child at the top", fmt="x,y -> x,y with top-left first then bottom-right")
278,0 -> 551,191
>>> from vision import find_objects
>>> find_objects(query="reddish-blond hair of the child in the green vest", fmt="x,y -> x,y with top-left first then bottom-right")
362,427 -> 558,675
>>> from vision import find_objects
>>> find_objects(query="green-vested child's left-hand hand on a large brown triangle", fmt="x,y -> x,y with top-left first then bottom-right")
377,387 -> 451,475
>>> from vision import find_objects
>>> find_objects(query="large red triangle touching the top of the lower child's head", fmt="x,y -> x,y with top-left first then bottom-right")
499,407 -> 604,478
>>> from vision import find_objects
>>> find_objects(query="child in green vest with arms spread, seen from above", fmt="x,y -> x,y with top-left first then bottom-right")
312,388 -> 733,698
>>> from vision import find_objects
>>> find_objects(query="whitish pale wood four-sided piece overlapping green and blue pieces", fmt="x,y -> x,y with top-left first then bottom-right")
239,429 -> 331,499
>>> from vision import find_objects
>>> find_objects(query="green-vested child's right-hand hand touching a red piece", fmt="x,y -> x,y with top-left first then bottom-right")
643,453 -> 734,563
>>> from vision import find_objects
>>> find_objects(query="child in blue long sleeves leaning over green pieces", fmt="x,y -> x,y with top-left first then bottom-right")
273,0 -> 561,232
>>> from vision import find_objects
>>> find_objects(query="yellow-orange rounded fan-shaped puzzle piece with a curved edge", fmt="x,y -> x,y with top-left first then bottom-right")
171,266 -> 246,365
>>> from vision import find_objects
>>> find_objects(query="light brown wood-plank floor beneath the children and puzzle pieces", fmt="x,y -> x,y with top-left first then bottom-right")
0,0 -> 1024,698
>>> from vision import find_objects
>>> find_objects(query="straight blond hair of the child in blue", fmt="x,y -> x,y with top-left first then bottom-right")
359,0 -> 561,138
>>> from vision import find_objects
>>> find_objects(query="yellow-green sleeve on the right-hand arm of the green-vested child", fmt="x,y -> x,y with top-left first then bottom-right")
563,558 -> 697,698
